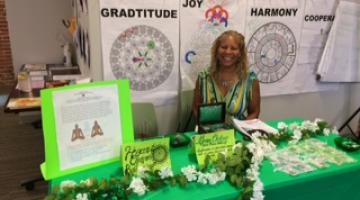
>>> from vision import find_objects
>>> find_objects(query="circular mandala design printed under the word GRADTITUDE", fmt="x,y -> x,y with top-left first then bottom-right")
110,25 -> 174,91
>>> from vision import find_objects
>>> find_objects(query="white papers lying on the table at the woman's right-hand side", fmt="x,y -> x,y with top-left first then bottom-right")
233,118 -> 278,137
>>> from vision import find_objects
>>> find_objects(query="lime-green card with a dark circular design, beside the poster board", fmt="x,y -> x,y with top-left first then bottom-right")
121,138 -> 171,174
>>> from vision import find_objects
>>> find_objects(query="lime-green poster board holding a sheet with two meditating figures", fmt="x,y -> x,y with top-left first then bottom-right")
40,80 -> 134,180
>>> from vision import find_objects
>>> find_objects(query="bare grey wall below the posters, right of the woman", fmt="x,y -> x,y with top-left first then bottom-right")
260,84 -> 350,127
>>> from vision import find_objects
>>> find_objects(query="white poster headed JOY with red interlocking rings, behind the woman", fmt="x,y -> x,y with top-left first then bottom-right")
180,0 -> 246,90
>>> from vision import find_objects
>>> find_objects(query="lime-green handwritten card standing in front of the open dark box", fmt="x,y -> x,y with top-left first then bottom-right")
193,129 -> 235,166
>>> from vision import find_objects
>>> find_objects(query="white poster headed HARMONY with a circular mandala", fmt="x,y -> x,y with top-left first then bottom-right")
245,0 -> 305,96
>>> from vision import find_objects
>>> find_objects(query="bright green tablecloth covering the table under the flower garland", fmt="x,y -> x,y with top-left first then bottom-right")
50,119 -> 360,200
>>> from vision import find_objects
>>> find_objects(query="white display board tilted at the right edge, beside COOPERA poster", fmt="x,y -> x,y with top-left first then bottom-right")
317,1 -> 360,82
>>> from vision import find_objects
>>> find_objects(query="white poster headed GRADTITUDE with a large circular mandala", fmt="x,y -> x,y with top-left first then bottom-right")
100,0 -> 179,105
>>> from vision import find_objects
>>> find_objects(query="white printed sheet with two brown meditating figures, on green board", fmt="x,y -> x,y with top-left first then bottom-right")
53,85 -> 122,170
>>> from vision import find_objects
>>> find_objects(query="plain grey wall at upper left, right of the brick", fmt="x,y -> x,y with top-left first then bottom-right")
5,0 -> 72,73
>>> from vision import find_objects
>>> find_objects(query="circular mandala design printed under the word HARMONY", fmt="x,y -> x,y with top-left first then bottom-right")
247,22 -> 296,83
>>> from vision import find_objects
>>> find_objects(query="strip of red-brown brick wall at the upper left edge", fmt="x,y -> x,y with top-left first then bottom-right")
0,0 -> 15,86
